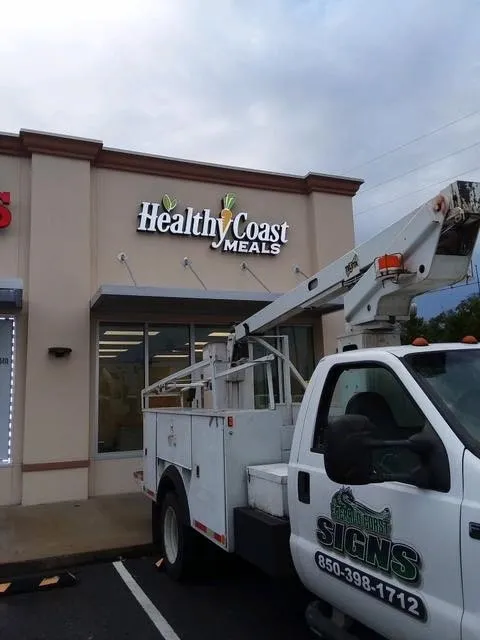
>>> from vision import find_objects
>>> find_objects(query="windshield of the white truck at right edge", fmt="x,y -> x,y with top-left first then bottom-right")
405,348 -> 480,445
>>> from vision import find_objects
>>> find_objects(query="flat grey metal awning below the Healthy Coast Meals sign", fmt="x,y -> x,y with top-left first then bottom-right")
90,284 -> 342,321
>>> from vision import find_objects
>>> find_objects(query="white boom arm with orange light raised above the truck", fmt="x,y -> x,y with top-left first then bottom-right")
230,181 -> 480,348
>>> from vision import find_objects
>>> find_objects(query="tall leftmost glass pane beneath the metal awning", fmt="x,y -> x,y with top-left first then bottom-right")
98,324 -> 145,453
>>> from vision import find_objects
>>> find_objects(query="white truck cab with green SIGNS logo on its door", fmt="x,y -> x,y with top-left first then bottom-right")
288,340 -> 480,640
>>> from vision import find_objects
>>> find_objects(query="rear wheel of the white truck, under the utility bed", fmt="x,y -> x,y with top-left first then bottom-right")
160,492 -> 194,580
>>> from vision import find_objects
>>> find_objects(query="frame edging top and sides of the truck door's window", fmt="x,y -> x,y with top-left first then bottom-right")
310,360 -> 429,455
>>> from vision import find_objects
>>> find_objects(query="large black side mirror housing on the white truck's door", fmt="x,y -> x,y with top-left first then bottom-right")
324,415 -> 375,485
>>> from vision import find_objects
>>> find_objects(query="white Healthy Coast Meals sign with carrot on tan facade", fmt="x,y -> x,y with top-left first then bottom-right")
137,193 -> 289,255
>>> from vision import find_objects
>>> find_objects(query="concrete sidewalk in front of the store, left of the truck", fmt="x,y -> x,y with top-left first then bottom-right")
0,493 -> 152,577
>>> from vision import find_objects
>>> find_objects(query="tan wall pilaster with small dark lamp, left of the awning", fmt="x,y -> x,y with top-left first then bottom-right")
23,154 -> 91,504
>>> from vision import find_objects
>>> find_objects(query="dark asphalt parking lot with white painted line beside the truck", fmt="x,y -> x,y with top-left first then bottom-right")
0,554 -> 382,640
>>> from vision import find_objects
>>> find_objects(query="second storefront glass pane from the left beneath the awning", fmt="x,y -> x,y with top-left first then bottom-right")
148,325 -> 191,407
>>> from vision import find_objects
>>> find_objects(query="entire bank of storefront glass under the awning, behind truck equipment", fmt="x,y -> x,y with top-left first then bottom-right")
97,323 -> 315,453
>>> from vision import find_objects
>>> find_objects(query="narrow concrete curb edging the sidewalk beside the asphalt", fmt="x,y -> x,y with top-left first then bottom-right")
0,543 -> 155,582
